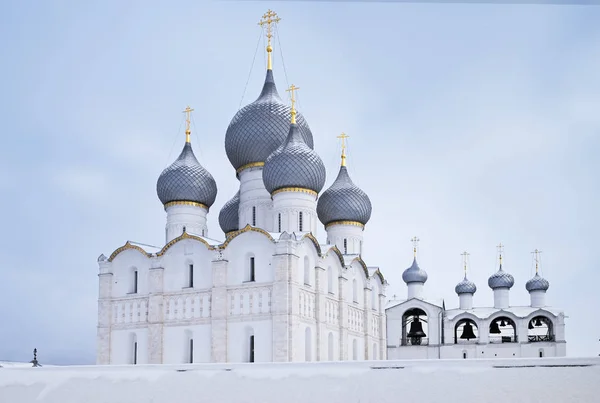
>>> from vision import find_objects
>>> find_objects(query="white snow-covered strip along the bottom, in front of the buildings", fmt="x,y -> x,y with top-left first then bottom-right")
0,358 -> 600,403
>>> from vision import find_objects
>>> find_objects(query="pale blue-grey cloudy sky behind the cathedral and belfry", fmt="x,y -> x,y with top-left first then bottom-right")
0,0 -> 600,364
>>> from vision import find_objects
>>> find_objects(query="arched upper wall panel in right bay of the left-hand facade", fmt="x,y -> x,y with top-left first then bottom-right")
223,231 -> 275,286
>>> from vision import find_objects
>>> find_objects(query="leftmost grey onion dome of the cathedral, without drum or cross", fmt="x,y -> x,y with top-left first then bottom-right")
156,142 -> 217,207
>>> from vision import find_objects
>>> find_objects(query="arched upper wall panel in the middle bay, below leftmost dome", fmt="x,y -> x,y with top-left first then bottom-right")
161,239 -> 213,292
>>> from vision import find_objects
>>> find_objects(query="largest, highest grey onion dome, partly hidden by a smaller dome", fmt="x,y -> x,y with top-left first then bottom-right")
225,70 -> 313,170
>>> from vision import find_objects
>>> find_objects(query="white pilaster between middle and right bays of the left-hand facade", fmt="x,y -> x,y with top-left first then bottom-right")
210,249 -> 229,362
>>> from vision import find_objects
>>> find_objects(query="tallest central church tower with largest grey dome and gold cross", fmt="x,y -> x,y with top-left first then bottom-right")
223,10 -> 313,231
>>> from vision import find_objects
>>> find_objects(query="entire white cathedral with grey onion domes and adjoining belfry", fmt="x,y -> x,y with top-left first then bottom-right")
97,10 -> 565,364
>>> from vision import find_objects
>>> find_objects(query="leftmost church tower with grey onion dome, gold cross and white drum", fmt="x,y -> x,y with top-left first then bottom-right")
156,106 -> 217,243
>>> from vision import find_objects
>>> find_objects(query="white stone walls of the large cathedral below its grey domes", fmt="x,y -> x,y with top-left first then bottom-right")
97,186 -> 386,364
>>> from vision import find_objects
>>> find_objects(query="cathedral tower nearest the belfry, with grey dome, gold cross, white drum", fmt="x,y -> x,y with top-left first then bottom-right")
317,133 -> 371,255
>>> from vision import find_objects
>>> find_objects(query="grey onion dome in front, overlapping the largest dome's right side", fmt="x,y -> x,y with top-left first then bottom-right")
263,123 -> 326,193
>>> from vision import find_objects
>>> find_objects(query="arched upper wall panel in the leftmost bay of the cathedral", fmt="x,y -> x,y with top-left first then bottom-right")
111,249 -> 150,298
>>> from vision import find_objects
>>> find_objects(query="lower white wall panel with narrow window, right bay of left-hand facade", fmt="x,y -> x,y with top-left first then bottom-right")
227,319 -> 273,362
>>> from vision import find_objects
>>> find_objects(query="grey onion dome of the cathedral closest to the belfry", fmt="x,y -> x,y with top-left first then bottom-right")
317,166 -> 372,225
